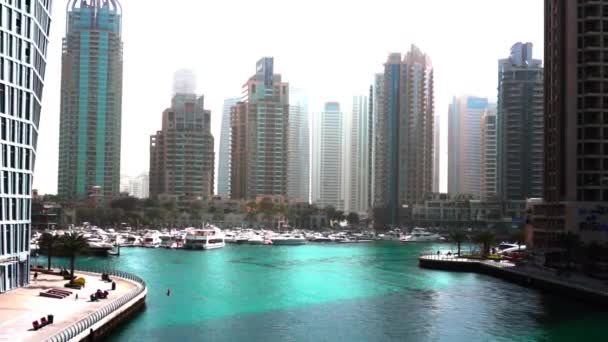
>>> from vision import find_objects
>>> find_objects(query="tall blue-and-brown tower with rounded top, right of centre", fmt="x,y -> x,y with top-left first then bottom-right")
374,46 -> 434,226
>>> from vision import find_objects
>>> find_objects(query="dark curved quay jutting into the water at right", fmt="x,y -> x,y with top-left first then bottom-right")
418,253 -> 608,306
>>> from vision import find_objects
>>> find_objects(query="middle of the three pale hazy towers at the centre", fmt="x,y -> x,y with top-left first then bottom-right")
312,102 -> 344,210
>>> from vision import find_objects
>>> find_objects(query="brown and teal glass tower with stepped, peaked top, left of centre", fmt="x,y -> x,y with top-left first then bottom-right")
230,57 -> 289,199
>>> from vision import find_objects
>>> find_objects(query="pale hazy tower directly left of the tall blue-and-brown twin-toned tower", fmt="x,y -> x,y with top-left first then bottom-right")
344,96 -> 371,213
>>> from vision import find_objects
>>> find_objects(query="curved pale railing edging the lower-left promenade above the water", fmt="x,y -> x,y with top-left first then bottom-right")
42,265 -> 146,342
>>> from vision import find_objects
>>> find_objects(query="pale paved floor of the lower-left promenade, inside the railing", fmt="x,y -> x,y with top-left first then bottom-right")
0,271 -> 137,342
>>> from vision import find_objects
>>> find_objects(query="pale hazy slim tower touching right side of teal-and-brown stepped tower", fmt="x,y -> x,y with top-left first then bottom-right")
287,87 -> 310,202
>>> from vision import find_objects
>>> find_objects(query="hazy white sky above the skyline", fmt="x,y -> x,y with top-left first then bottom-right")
34,0 -> 543,193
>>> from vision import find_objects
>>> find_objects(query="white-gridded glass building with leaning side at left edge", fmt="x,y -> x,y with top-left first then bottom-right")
0,0 -> 52,293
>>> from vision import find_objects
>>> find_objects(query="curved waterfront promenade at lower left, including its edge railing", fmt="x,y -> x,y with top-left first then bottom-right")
0,271 -> 146,342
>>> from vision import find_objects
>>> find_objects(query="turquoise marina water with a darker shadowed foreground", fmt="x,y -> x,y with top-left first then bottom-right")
34,242 -> 608,341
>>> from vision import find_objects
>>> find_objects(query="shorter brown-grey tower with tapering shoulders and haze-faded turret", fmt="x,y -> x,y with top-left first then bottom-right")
149,72 -> 215,206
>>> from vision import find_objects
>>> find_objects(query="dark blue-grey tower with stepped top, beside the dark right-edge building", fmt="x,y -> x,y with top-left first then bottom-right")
497,43 -> 544,201
